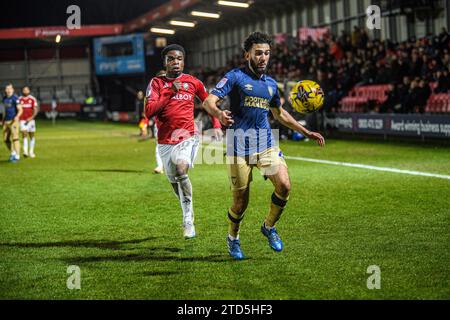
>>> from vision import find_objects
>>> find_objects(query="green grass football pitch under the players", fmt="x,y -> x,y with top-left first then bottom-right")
0,121 -> 450,299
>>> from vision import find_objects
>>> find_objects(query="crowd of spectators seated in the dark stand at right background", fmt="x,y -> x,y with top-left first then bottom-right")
193,26 -> 450,113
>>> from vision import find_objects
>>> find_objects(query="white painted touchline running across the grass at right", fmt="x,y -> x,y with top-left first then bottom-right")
203,146 -> 450,180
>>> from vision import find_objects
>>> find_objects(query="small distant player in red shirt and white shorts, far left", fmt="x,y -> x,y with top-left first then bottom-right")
19,86 -> 39,158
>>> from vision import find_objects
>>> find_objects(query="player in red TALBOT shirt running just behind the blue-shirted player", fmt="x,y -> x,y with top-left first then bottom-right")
145,44 -> 223,239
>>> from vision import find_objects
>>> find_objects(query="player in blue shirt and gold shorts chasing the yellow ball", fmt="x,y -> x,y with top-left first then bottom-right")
203,32 -> 325,260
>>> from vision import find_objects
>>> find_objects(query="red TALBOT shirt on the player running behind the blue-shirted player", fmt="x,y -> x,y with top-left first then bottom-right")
145,73 -> 221,144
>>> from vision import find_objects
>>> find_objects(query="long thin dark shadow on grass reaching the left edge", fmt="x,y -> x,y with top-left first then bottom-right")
0,237 -> 156,250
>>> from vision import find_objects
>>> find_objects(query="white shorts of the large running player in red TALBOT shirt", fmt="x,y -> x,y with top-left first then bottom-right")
158,136 -> 200,183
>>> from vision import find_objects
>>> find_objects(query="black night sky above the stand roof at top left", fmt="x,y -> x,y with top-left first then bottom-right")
0,0 -> 168,28
